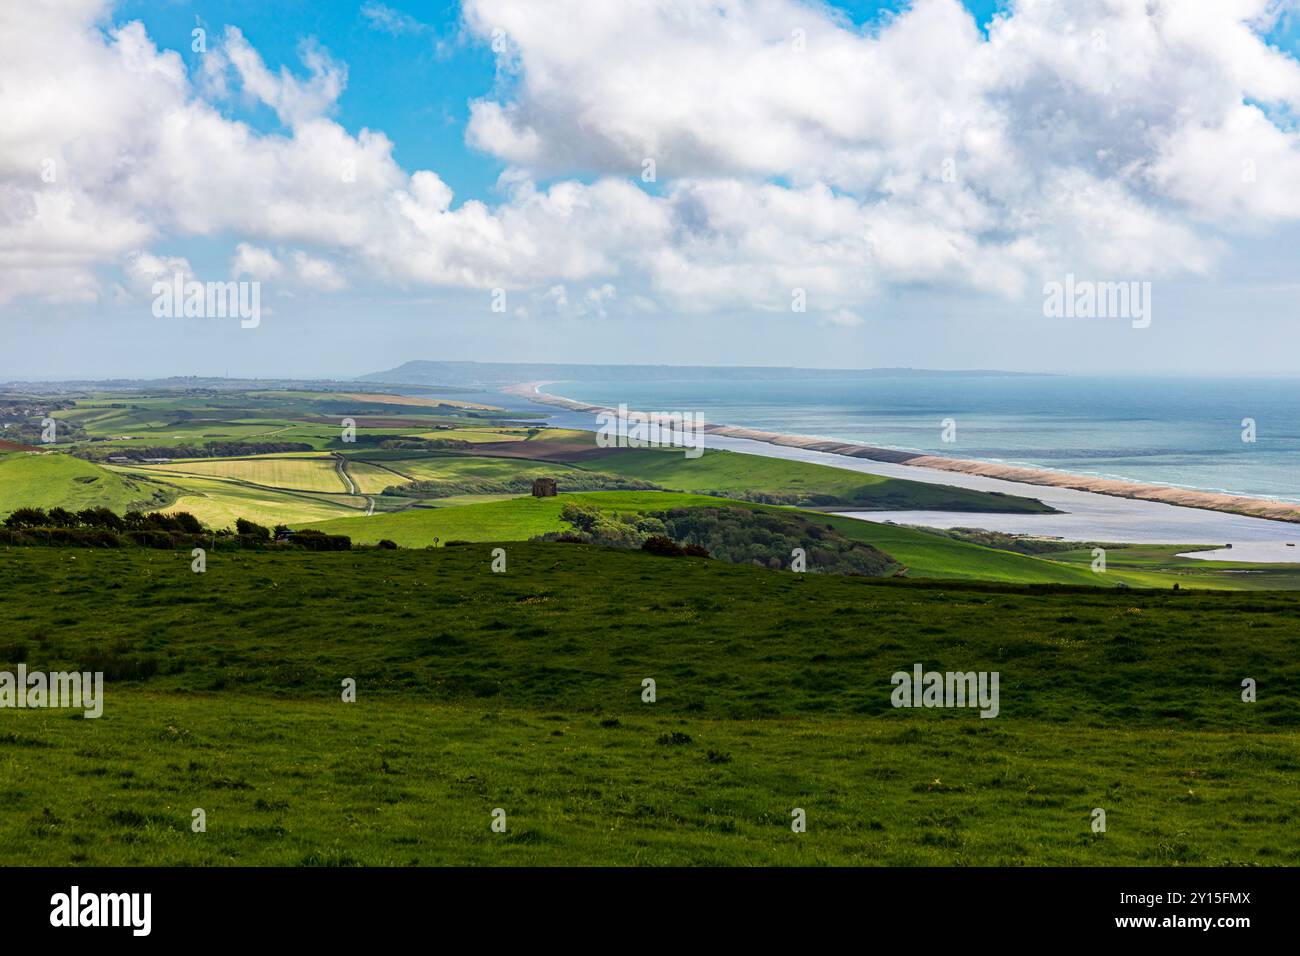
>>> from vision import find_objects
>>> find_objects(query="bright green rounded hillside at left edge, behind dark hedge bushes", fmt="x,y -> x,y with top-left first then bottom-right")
0,451 -> 176,518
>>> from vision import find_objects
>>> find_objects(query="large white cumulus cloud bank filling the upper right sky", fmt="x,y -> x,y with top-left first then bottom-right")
465,0 -> 1300,302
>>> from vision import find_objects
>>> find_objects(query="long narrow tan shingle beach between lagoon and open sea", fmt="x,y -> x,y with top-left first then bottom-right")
502,381 -> 1300,524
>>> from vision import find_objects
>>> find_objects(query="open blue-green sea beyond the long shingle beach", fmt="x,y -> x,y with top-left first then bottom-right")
543,373 -> 1300,502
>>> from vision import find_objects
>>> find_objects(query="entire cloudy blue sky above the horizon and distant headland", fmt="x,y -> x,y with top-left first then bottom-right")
0,0 -> 1300,377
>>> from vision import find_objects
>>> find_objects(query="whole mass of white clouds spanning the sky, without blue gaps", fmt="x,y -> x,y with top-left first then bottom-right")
0,0 -> 1300,319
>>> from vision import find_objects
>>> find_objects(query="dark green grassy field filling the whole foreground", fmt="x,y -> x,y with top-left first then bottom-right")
0,544 -> 1300,865
